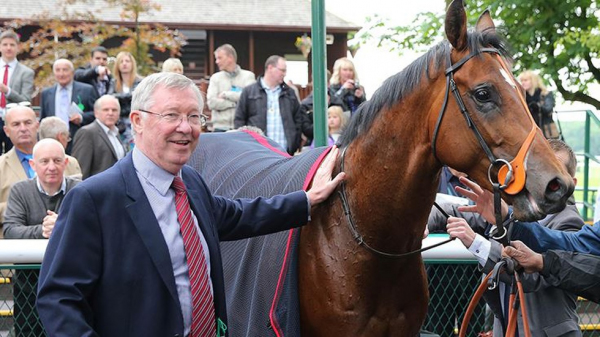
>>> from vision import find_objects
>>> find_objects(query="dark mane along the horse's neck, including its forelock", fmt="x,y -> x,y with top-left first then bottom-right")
337,26 -> 510,148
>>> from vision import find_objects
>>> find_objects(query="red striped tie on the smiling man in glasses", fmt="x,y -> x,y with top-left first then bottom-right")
171,177 -> 217,337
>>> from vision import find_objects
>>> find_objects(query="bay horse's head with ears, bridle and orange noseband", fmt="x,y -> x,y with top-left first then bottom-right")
430,0 -> 575,220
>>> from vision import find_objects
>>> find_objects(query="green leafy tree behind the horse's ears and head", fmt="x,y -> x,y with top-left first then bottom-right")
358,0 -> 600,109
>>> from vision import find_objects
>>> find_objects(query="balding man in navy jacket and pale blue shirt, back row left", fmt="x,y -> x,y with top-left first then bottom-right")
40,59 -> 98,154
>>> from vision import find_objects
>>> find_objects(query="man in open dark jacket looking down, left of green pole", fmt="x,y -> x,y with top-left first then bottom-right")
234,55 -> 313,154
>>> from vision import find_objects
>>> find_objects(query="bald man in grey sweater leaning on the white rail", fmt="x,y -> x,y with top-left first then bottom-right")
4,138 -> 80,336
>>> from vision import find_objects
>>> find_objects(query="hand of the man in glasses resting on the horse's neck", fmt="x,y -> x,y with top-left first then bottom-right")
306,146 -> 346,206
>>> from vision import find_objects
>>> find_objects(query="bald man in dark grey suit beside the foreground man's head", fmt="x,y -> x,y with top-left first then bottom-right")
73,95 -> 127,179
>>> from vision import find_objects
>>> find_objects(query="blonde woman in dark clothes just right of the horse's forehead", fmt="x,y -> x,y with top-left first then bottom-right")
519,70 -> 554,138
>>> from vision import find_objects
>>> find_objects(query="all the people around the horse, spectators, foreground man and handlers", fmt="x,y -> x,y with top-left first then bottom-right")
0,26 -> 600,336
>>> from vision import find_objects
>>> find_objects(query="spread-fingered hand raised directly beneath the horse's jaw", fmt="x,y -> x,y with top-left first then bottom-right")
455,177 -> 508,224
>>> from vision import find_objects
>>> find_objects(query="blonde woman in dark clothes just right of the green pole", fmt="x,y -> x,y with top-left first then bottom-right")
329,57 -> 366,114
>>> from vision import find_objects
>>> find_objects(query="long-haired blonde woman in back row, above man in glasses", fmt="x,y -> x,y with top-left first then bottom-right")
112,51 -> 142,151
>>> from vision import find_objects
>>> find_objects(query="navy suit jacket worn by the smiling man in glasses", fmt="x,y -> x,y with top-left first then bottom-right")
37,154 -> 308,337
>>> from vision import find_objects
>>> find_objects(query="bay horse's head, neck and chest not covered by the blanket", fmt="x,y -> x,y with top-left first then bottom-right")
298,0 -> 574,336
